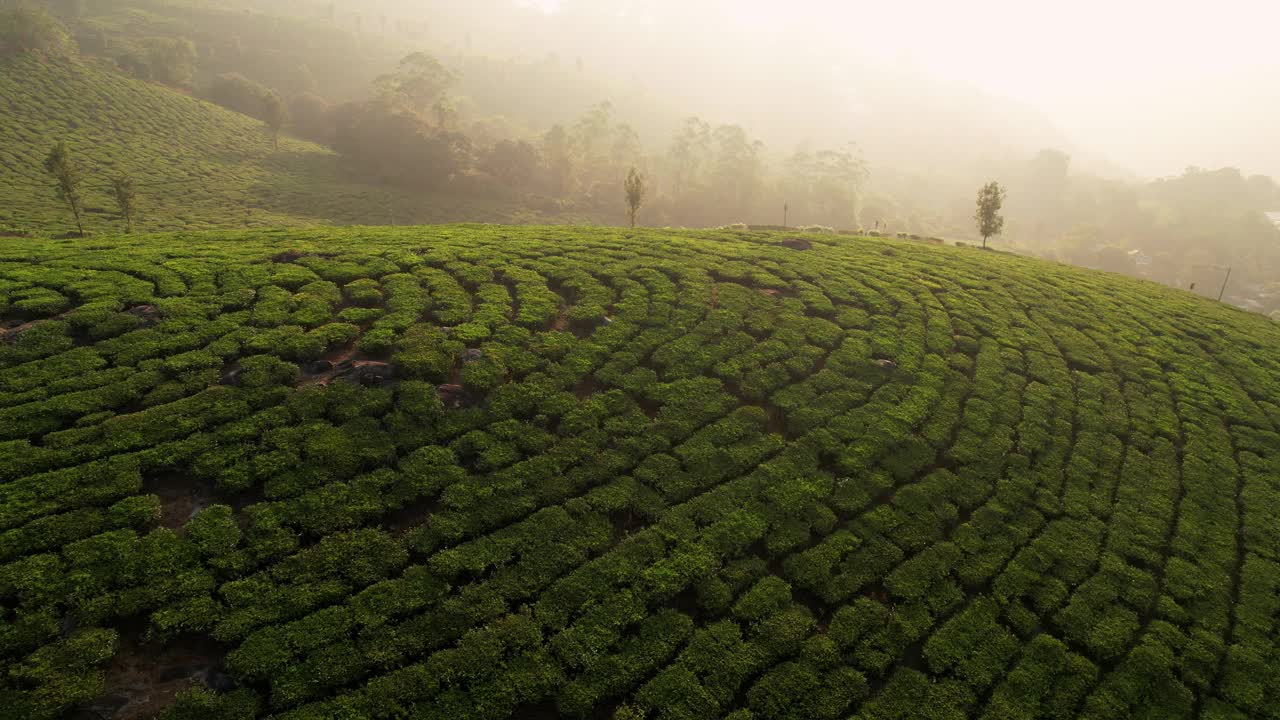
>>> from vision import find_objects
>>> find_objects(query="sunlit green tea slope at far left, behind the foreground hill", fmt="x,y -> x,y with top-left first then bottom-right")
0,54 -> 558,234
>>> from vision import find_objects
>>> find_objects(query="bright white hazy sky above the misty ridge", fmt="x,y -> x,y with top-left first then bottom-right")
530,0 -> 1280,177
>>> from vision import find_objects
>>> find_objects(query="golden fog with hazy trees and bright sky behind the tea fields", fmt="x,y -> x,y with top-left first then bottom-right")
35,0 -> 1280,299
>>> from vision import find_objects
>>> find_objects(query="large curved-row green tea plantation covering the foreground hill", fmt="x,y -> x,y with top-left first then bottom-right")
0,225 -> 1280,720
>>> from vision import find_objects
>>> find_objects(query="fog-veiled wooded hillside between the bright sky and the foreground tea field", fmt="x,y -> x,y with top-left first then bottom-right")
24,0 -> 1280,311
